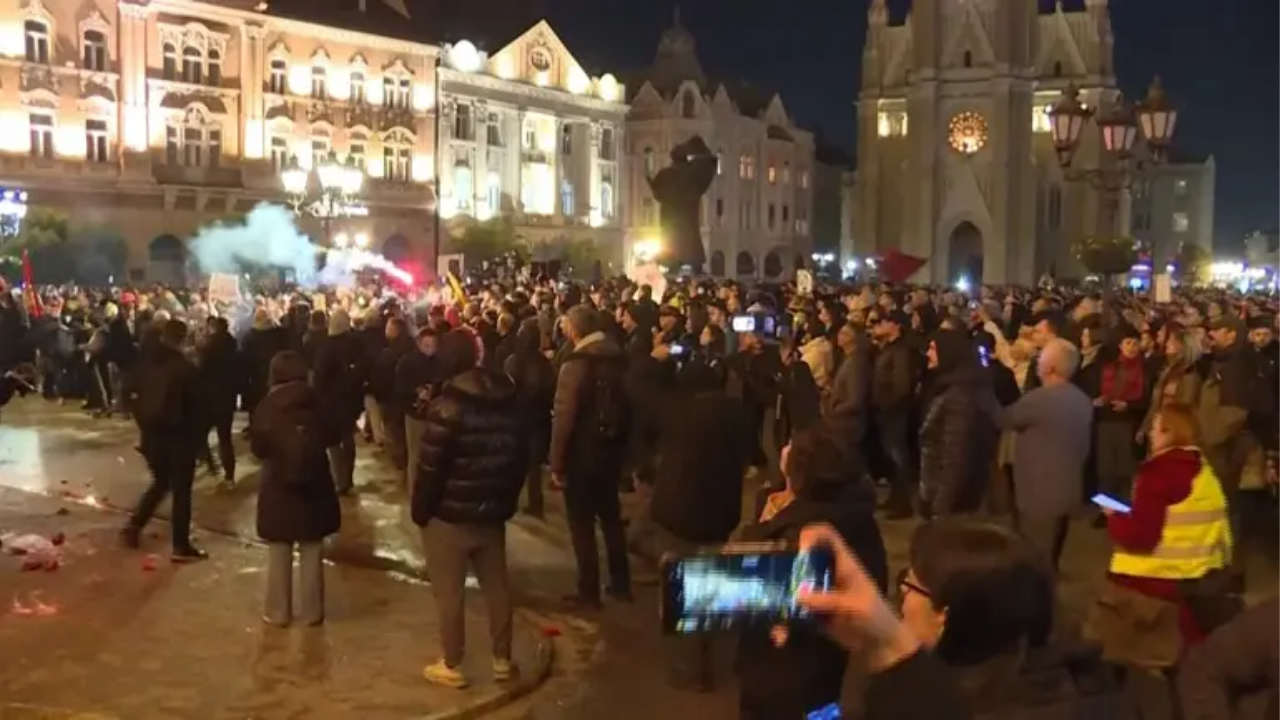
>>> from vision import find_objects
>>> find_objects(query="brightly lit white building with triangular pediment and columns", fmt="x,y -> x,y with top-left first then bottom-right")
439,20 -> 627,260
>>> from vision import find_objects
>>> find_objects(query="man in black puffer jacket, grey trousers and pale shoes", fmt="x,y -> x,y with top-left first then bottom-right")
412,329 -> 529,688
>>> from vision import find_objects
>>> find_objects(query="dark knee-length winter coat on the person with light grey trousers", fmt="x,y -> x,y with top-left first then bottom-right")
250,380 -> 342,542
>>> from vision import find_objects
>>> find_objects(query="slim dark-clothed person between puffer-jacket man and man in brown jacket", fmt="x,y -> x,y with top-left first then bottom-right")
503,318 -> 556,519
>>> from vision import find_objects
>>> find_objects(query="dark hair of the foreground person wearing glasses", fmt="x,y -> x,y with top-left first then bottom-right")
906,515 -> 1056,666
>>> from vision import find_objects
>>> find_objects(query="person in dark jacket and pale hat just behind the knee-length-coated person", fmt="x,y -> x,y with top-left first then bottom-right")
314,307 -> 369,496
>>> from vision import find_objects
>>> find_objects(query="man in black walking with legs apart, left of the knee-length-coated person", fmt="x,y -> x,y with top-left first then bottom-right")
120,320 -> 207,562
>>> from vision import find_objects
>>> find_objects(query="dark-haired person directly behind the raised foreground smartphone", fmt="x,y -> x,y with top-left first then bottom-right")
735,425 -> 888,720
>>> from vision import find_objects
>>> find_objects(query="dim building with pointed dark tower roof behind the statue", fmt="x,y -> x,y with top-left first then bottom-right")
625,12 -> 814,278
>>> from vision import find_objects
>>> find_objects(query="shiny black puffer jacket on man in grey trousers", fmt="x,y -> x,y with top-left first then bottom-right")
412,368 -> 529,527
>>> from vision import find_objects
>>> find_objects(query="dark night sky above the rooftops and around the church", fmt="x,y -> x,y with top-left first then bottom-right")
534,0 -> 1280,251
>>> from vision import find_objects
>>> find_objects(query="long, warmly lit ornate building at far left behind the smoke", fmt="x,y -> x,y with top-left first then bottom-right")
0,0 -> 436,279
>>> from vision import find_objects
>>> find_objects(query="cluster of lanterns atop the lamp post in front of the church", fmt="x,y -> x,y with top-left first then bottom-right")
1048,77 -> 1178,235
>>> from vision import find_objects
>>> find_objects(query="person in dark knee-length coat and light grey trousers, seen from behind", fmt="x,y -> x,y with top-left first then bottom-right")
250,350 -> 344,628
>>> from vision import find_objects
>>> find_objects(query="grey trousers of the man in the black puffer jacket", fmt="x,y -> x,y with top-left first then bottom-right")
422,520 -> 512,667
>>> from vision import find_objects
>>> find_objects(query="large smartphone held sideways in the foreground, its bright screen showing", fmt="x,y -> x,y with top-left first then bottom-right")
660,543 -> 835,634
